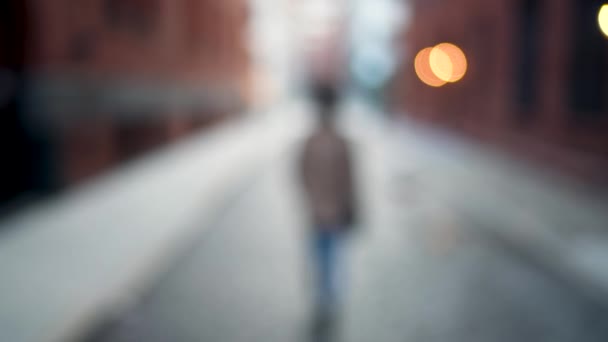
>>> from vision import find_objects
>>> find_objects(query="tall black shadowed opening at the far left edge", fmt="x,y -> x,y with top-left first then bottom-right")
0,0 -> 53,208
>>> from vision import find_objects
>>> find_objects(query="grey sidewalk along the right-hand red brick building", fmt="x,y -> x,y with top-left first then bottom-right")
364,107 -> 608,309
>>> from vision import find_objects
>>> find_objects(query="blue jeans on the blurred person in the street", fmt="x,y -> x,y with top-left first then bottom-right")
313,227 -> 343,306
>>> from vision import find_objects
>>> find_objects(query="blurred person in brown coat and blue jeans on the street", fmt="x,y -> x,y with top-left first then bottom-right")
300,84 -> 356,332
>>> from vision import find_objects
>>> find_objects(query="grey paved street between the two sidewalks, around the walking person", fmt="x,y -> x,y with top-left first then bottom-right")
87,104 -> 608,342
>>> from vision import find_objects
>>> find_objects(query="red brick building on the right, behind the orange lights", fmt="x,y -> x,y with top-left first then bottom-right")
391,0 -> 608,179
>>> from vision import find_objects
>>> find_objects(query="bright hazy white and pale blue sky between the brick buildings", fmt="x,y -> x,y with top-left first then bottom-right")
250,0 -> 408,96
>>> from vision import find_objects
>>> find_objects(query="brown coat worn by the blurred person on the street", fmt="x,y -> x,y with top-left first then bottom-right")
301,125 -> 354,229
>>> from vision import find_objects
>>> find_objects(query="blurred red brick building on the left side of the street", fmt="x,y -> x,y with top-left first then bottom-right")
0,0 -> 249,203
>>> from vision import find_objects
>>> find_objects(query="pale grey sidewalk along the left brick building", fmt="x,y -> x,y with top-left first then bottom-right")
0,103 -> 306,342
